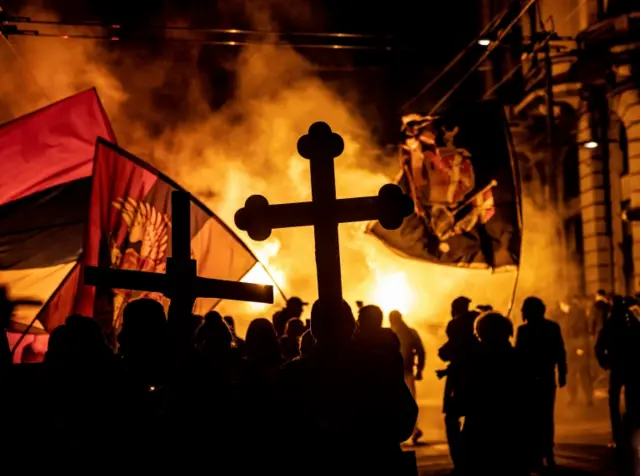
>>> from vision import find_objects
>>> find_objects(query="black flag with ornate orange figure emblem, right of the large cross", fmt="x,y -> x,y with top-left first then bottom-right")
367,101 -> 522,269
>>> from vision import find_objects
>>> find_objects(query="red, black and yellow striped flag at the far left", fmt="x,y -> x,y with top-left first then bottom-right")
0,89 -> 115,333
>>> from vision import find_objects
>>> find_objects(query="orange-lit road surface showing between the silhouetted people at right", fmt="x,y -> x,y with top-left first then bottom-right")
406,389 -> 615,476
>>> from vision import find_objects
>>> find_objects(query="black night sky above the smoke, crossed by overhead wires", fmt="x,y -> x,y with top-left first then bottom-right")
3,0 -> 488,143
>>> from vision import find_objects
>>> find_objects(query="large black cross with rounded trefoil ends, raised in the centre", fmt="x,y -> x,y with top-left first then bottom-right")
235,122 -> 413,310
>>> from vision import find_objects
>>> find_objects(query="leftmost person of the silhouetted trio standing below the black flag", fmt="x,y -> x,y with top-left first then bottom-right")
437,296 -> 479,468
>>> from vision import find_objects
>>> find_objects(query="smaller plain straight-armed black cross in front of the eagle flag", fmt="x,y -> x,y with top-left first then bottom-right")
84,190 -> 273,328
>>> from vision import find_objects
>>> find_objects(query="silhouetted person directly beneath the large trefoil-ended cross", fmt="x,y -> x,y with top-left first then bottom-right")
281,301 -> 417,475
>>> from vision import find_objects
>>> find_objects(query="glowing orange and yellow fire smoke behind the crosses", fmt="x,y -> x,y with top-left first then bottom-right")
0,2 -> 566,331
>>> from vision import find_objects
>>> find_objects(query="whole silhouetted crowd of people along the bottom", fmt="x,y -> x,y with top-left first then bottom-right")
0,290 -> 640,476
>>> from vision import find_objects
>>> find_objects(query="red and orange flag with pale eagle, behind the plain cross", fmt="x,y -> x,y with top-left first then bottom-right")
50,140 -> 258,332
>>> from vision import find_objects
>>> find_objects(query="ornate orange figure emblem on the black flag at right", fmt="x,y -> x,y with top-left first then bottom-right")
400,114 -> 497,252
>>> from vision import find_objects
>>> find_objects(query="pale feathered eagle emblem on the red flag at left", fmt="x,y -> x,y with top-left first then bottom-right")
109,197 -> 171,328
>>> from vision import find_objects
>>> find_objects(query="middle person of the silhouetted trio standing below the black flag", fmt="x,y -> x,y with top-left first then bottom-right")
463,312 -> 529,476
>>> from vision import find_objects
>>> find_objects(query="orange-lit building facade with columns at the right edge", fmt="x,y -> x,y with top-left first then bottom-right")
485,0 -> 640,294
